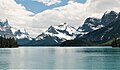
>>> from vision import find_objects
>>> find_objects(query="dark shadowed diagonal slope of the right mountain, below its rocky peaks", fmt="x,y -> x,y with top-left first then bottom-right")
76,14 -> 120,42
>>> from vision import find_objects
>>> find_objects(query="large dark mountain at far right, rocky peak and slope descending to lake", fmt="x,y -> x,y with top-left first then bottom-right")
63,11 -> 120,45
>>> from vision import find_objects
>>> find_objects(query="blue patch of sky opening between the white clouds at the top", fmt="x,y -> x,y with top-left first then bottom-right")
16,0 -> 86,14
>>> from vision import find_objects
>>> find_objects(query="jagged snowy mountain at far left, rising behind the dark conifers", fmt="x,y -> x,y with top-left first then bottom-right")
0,19 -> 32,45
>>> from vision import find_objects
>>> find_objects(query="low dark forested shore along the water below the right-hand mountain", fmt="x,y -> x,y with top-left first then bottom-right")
61,36 -> 120,47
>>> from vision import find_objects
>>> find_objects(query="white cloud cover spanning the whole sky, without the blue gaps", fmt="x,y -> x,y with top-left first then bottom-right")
0,0 -> 120,35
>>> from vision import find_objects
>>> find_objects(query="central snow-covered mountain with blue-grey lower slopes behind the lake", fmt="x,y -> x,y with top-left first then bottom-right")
31,23 -> 76,46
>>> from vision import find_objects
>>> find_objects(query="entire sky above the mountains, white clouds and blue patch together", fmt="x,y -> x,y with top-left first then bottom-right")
0,0 -> 120,36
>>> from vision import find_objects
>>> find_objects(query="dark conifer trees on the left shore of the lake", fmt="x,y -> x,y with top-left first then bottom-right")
0,36 -> 18,48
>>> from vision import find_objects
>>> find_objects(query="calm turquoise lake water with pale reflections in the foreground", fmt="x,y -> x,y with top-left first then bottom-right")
0,47 -> 120,70
